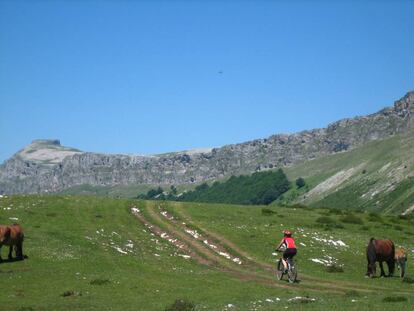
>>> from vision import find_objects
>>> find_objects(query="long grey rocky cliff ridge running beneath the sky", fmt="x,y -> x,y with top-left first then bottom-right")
0,92 -> 414,194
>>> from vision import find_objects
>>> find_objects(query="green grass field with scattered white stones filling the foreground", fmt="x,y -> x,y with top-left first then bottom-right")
0,196 -> 414,310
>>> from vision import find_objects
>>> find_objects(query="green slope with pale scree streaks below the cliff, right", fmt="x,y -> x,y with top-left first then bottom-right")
284,132 -> 414,213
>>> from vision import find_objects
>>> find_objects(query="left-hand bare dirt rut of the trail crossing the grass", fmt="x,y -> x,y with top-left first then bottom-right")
140,202 -> 371,294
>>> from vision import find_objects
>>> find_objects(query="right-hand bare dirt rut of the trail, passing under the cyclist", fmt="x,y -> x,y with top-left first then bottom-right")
174,206 -> 414,294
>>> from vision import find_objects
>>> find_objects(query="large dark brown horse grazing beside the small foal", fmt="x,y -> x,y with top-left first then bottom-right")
366,238 -> 395,278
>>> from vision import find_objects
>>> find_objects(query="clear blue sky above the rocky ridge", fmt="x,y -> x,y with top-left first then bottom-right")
0,0 -> 414,162
